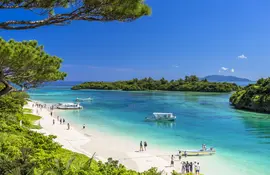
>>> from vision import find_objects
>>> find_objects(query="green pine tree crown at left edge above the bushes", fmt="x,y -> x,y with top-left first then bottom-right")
0,38 -> 66,96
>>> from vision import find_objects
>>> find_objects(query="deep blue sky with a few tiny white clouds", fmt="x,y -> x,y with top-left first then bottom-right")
0,0 -> 270,81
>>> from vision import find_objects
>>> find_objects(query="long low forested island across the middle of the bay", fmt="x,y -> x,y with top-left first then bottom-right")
72,75 -> 241,92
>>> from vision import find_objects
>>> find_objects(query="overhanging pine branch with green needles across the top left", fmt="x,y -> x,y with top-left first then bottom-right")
0,0 -> 151,30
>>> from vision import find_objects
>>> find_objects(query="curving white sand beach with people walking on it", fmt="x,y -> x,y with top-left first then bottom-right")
25,102 -> 243,175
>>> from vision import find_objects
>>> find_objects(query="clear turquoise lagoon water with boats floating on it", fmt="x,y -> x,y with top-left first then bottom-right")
29,82 -> 270,175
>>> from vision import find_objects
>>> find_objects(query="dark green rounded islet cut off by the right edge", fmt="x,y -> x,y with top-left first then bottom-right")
230,77 -> 270,113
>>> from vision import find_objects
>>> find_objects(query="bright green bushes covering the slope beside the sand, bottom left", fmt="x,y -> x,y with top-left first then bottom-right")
0,92 -> 167,175
